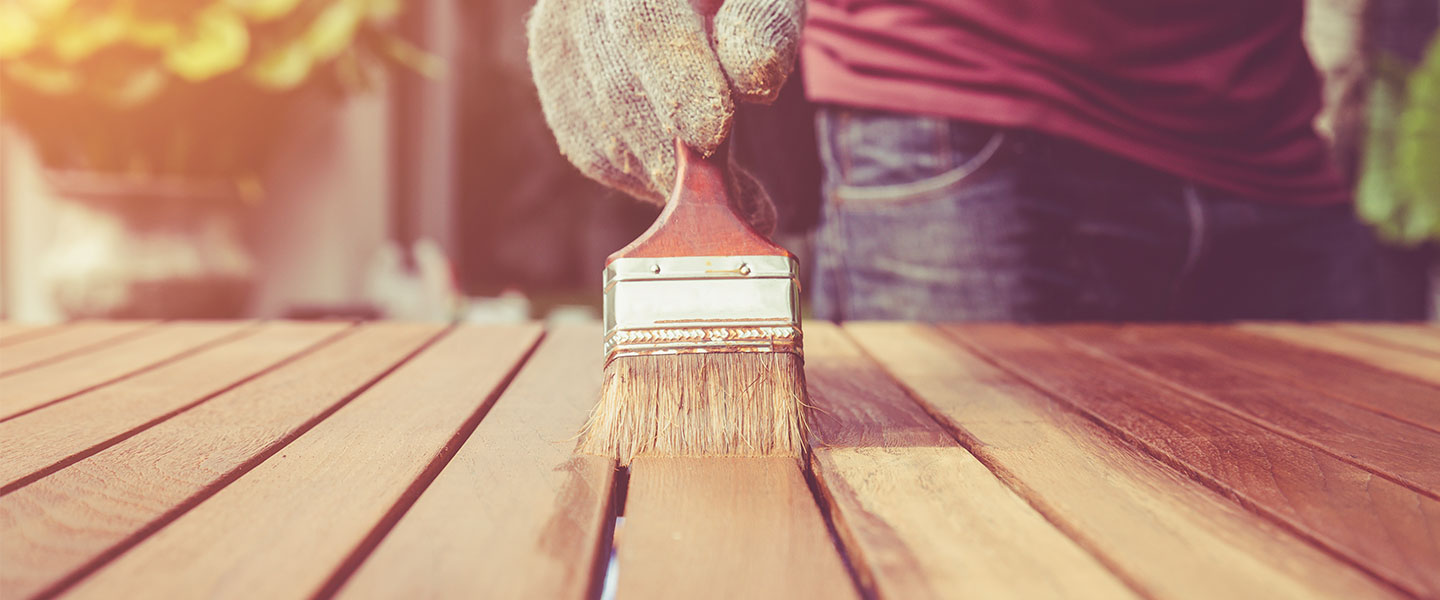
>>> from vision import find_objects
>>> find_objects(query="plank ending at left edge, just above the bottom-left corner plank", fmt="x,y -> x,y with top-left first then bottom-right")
0,322 -> 348,494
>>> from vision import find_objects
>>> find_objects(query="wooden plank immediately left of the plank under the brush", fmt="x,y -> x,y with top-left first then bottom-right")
340,325 -> 615,599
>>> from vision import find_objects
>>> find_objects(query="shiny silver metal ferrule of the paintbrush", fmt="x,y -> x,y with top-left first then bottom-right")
605,256 -> 801,364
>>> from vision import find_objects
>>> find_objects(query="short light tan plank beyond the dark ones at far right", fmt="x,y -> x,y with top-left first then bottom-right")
1240,322 -> 1440,384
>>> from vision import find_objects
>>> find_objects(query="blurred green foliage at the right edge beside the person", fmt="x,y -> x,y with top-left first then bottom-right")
1356,36 -> 1440,246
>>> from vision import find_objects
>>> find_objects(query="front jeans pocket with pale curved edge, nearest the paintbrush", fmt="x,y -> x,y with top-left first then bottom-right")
829,120 -> 1005,210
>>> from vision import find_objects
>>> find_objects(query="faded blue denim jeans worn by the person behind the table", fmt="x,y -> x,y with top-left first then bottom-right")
811,106 -> 1382,321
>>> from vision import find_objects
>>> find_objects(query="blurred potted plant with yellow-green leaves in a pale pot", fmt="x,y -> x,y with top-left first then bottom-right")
0,0 -> 433,318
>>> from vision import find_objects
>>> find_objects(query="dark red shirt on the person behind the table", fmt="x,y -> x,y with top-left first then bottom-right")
802,0 -> 1349,204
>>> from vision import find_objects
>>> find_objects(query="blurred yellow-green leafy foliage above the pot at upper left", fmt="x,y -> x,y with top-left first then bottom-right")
0,0 -> 433,178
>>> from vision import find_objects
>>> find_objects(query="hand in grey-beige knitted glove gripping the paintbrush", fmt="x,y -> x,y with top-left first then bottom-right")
527,0 -> 805,235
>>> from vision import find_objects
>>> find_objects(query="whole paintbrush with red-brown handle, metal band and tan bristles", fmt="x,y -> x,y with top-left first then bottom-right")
580,141 -> 805,465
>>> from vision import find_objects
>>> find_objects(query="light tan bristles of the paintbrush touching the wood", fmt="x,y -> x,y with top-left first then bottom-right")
580,353 -> 806,465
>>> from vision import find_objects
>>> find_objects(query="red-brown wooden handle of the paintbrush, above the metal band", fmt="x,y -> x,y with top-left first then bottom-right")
606,140 -> 791,265
